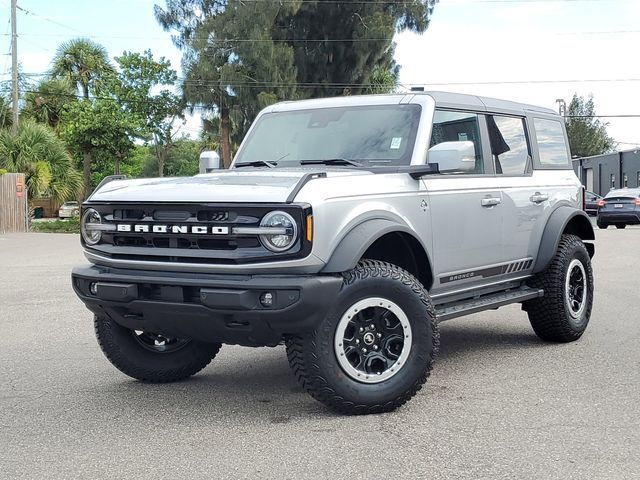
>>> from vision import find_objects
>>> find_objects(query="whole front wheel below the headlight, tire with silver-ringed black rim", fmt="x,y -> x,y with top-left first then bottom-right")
286,260 -> 439,414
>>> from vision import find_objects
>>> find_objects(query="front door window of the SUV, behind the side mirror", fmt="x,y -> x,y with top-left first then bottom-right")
429,110 -> 485,175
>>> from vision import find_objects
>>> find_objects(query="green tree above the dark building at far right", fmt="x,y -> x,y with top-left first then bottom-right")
566,94 -> 617,157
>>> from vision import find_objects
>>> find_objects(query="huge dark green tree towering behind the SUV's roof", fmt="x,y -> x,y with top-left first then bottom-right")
156,0 -> 436,166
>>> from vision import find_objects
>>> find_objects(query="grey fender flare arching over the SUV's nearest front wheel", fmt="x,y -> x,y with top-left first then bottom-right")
322,218 -> 430,273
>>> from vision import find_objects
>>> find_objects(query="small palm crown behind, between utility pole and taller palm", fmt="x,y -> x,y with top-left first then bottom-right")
22,78 -> 77,130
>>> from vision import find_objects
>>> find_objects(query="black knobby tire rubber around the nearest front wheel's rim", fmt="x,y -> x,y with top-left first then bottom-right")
286,260 -> 440,415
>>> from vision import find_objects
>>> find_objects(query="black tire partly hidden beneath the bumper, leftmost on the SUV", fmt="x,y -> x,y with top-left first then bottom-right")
94,316 -> 221,383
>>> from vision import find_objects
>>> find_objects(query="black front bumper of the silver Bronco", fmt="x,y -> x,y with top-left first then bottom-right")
71,265 -> 342,346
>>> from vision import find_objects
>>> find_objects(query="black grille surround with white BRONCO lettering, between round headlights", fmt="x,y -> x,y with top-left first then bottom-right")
82,202 -> 312,265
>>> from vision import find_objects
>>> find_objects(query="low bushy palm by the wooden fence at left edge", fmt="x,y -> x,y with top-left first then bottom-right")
0,120 -> 82,202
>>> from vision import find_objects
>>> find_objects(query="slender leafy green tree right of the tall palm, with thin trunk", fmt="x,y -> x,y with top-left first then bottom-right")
113,50 -> 184,177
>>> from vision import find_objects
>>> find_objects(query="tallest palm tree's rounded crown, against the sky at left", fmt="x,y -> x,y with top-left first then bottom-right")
51,38 -> 115,100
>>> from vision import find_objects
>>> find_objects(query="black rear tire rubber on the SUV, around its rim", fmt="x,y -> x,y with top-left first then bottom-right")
524,235 -> 593,342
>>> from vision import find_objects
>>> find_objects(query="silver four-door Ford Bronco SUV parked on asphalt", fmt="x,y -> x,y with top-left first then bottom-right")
73,93 -> 594,413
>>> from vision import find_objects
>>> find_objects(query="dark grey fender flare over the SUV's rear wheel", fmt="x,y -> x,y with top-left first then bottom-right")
533,206 -> 596,273
